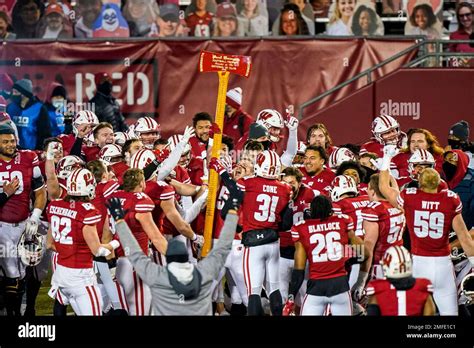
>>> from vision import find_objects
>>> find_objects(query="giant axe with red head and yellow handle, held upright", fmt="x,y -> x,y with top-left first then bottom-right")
199,51 -> 252,256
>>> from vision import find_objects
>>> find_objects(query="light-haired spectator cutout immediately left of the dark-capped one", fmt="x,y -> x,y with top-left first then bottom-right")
122,0 -> 160,37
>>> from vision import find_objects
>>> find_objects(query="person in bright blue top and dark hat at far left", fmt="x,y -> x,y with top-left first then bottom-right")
7,79 -> 51,150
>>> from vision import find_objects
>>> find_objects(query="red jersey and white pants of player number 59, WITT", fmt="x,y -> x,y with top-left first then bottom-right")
397,188 -> 462,315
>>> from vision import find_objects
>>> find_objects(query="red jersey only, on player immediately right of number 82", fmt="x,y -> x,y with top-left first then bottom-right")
112,190 -> 155,257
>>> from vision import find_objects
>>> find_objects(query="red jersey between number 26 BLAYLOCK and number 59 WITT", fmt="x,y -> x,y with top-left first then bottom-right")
362,201 -> 406,265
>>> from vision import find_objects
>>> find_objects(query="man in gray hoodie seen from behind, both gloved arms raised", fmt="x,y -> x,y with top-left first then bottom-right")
108,190 -> 242,315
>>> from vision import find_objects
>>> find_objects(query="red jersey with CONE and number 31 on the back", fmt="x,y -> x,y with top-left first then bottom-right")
237,176 -> 291,233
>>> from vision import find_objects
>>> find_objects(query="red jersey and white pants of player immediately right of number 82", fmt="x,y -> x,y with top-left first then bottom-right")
112,191 -> 155,315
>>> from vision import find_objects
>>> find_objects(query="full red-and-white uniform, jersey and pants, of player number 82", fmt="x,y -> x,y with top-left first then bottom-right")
47,199 -> 102,315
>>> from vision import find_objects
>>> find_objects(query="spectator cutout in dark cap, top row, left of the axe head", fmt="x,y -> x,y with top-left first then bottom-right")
148,4 -> 189,37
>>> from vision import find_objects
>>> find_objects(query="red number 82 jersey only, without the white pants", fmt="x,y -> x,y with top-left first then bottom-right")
48,199 -> 101,268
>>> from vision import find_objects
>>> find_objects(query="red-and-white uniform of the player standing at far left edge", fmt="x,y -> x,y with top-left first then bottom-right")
0,150 -> 44,278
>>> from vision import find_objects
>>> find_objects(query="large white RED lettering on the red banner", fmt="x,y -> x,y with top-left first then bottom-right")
75,72 -> 150,106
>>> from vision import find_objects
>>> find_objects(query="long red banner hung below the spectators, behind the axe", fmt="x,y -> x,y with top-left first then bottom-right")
0,39 -> 416,136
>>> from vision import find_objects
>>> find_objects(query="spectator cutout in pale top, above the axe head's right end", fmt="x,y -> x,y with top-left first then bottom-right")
236,0 -> 268,36
